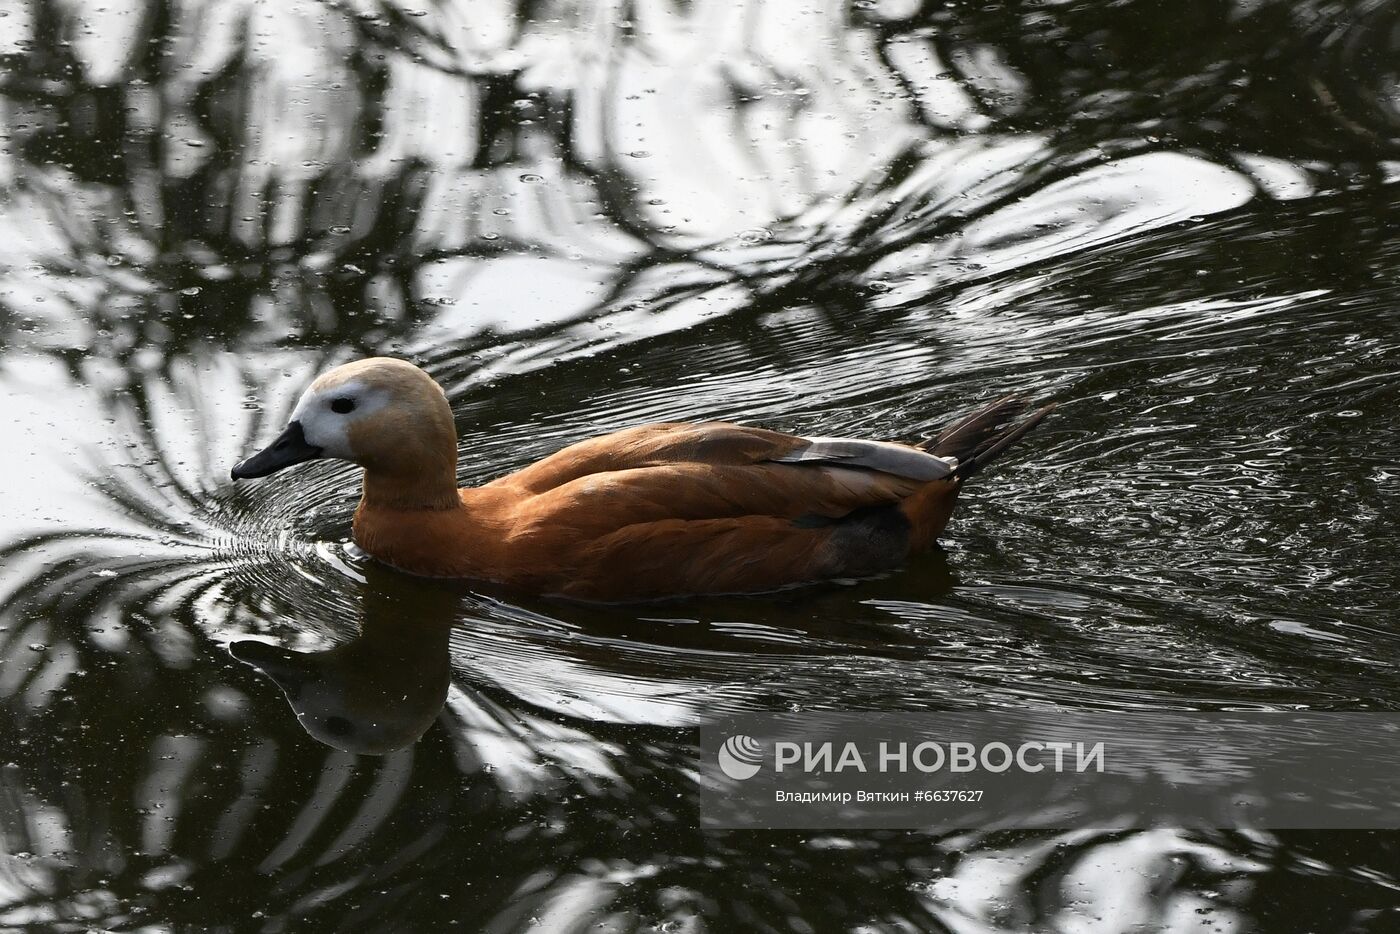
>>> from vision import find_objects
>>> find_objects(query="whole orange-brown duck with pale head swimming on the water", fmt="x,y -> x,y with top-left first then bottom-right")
232,357 -> 1054,602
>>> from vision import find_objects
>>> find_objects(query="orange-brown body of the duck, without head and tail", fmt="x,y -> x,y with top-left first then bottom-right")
354,423 -> 959,601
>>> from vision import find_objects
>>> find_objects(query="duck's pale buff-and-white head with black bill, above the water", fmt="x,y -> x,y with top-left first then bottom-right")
232,357 -> 456,504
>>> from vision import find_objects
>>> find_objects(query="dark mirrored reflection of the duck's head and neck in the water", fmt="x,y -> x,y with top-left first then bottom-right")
228,569 -> 459,755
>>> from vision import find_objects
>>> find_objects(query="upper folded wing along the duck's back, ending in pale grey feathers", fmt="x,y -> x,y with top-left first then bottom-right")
497,421 -> 958,495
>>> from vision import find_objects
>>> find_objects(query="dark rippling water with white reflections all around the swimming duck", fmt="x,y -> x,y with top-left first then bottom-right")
0,0 -> 1400,931
